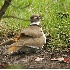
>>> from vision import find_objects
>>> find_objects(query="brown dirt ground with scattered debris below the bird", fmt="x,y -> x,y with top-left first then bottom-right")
0,46 -> 70,69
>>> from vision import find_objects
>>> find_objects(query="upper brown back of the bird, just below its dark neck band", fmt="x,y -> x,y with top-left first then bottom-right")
20,26 -> 42,38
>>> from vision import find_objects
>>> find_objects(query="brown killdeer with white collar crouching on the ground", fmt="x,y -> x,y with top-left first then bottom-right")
6,14 -> 46,54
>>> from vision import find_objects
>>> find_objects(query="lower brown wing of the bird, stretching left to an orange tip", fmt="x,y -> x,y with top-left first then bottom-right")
5,36 -> 45,54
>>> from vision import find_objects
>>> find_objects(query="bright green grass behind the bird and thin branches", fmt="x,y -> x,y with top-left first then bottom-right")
0,0 -> 70,46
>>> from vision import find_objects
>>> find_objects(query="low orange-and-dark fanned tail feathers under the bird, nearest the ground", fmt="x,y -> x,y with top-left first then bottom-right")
4,46 -> 39,55
